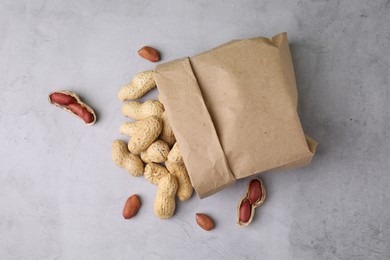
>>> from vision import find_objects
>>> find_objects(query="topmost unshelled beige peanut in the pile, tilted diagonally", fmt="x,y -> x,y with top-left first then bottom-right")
118,70 -> 156,101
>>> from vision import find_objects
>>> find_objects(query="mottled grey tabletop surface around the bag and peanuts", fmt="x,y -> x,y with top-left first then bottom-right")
0,0 -> 390,259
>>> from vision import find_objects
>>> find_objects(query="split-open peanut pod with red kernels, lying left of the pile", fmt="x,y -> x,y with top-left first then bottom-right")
48,90 -> 97,125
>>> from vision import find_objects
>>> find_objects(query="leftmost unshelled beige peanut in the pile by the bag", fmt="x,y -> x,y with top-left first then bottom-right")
112,140 -> 144,176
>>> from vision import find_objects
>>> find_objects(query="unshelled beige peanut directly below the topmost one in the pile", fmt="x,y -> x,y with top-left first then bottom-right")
122,100 -> 164,120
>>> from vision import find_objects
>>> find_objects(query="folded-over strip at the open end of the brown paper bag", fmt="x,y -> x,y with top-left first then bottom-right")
153,58 -> 235,198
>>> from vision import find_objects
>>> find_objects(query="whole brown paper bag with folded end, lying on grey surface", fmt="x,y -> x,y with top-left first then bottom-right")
154,33 -> 317,198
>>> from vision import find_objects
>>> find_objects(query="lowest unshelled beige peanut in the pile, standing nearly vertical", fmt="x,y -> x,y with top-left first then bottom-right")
153,174 -> 178,219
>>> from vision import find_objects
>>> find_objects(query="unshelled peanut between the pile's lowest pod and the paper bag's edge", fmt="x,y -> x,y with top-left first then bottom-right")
165,161 -> 194,201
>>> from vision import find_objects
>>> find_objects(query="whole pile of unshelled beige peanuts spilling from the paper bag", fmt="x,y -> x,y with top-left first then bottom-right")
112,70 -> 193,218
